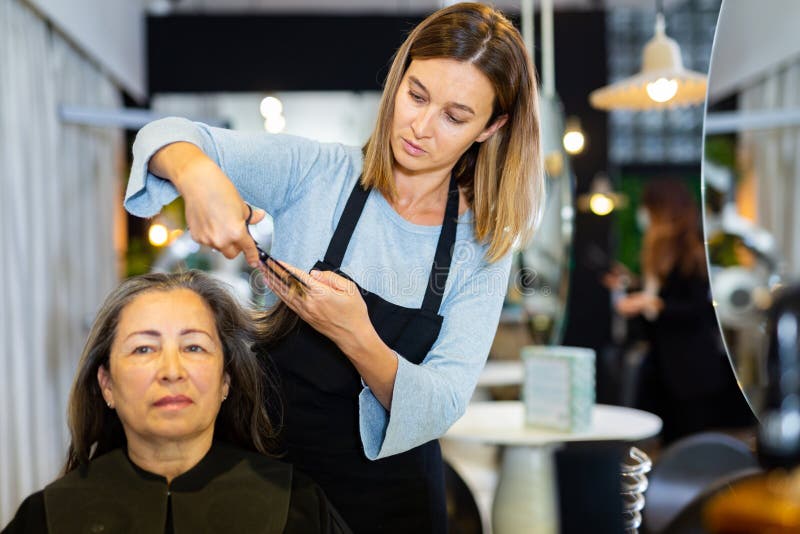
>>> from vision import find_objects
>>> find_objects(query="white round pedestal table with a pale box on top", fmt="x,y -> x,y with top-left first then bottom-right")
442,401 -> 661,534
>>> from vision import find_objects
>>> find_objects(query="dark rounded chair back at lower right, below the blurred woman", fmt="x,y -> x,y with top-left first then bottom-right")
642,432 -> 759,534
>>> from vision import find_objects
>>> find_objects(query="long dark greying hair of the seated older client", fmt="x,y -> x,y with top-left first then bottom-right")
64,271 -> 279,473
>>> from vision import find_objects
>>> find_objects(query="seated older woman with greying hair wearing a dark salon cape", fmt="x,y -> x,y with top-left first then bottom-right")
4,272 -> 350,534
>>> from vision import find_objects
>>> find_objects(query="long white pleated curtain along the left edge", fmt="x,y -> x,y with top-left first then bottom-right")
0,0 -> 124,526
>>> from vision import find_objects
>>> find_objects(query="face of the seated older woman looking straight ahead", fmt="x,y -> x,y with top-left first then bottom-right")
97,289 -> 229,446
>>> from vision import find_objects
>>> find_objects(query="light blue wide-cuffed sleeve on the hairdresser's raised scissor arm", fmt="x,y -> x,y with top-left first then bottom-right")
125,117 -> 360,217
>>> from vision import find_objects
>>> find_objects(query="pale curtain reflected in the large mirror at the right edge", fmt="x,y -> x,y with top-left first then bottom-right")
739,58 -> 800,280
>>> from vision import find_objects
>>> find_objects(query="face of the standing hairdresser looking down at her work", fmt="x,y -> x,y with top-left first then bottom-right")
391,59 -> 505,180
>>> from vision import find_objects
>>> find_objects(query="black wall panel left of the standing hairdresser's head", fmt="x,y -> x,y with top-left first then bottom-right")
147,15 -> 421,94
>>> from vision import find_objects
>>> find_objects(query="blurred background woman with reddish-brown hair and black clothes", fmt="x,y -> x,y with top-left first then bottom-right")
611,179 -> 753,443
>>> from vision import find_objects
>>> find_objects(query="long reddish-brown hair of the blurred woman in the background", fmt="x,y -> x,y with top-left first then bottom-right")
642,178 -> 706,283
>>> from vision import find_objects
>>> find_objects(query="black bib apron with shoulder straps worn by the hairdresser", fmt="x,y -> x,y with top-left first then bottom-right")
269,178 -> 458,534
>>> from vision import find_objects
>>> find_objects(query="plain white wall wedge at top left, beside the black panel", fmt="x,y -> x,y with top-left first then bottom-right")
28,0 -> 147,98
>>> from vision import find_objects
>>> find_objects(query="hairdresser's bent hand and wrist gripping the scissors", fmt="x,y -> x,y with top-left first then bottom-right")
149,143 -> 266,267
